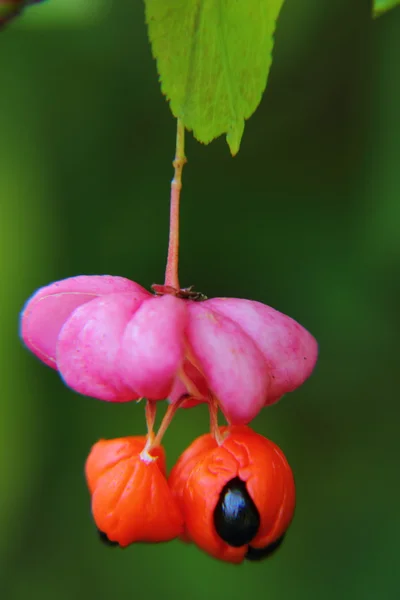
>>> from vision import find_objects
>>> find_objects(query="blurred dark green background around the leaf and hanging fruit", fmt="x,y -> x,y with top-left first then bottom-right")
0,0 -> 400,600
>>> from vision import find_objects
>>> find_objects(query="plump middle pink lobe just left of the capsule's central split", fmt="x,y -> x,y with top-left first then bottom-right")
118,295 -> 187,400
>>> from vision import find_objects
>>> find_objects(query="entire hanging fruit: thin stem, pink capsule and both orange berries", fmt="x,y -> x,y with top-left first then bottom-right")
21,121 -> 318,563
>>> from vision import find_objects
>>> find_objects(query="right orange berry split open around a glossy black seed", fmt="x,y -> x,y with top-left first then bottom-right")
169,426 -> 295,563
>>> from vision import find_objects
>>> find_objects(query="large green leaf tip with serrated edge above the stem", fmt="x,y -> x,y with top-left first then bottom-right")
145,0 -> 284,155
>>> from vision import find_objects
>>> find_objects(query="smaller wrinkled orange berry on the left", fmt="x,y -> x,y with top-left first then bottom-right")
85,436 -> 183,547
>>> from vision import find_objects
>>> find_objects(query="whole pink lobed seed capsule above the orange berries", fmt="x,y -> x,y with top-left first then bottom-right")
21,275 -> 318,424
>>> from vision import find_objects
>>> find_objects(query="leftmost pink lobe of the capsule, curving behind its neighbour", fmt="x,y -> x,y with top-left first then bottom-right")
21,275 -> 150,369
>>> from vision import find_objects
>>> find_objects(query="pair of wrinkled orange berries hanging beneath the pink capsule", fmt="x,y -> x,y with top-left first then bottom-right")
86,425 -> 295,563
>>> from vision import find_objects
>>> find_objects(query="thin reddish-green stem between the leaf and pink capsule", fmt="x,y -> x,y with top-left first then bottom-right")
165,119 -> 186,290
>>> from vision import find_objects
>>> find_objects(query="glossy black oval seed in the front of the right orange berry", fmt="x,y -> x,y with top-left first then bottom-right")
214,477 -> 260,548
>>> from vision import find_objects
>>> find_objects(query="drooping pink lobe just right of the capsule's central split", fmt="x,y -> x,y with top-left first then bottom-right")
187,302 -> 270,424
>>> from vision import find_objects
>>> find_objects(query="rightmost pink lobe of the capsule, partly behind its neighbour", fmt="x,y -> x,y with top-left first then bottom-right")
204,298 -> 318,404
